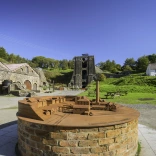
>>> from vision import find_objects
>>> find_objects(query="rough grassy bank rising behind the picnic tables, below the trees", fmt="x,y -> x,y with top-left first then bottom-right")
88,74 -> 156,93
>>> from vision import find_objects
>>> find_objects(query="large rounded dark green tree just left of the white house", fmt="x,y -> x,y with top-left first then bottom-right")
136,56 -> 149,72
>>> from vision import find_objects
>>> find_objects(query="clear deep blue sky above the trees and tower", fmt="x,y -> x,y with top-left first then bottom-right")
0,0 -> 156,65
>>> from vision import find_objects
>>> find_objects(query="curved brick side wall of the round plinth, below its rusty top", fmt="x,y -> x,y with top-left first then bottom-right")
18,118 -> 138,156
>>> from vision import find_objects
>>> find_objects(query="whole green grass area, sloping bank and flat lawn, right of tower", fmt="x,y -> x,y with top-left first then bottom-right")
80,74 -> 156,104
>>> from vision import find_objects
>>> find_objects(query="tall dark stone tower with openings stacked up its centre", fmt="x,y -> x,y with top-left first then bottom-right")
71,54 -> 95,88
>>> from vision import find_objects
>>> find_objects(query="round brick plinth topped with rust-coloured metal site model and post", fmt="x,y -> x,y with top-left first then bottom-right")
17,83 -> 139,156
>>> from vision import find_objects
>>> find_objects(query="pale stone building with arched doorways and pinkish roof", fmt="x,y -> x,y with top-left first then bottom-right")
0,62 -> 47,91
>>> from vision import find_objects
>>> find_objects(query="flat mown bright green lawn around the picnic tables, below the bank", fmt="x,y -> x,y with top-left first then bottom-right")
79,91 -> 156,104
